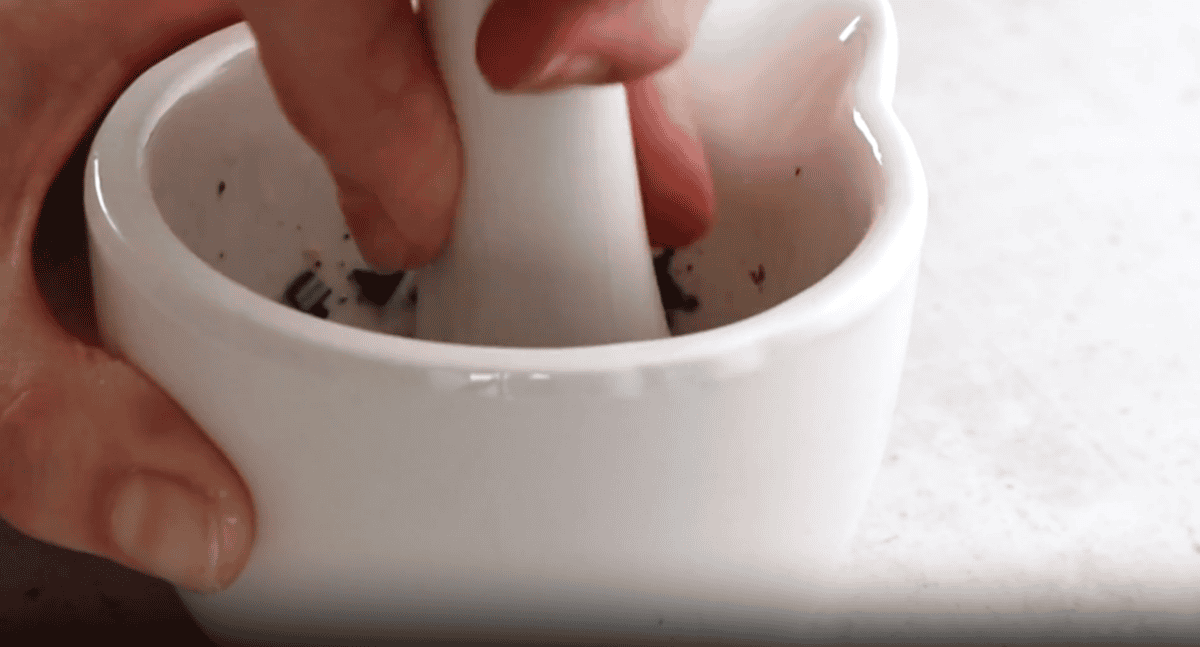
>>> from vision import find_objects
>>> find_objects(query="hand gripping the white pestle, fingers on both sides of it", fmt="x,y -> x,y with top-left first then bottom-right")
238,0 -> 714,270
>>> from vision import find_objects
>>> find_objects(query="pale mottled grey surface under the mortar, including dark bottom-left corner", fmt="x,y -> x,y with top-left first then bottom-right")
0,0 -> 1200,641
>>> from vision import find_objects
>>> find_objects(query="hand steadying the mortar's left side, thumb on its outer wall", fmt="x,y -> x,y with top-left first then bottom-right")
0,0 -> 254,591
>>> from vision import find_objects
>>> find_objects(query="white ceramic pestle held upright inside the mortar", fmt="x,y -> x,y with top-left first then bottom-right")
416,0 -> 670,347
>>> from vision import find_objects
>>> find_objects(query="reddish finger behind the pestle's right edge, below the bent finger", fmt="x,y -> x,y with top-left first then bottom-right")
626,65 -> 716,247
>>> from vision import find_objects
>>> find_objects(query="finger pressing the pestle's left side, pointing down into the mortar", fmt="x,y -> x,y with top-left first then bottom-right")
240,0 -> 462,271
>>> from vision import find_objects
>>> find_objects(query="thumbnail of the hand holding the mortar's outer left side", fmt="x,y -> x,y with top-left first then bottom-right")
110,473 -> 250,592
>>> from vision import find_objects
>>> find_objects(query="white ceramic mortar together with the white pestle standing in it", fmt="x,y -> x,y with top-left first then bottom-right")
85,0 -> 926,643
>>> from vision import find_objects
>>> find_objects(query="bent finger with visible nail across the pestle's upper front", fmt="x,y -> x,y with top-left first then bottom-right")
476,0 -> 708,91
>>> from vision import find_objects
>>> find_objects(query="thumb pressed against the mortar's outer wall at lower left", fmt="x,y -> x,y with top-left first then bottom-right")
0,319 -> 254,591
